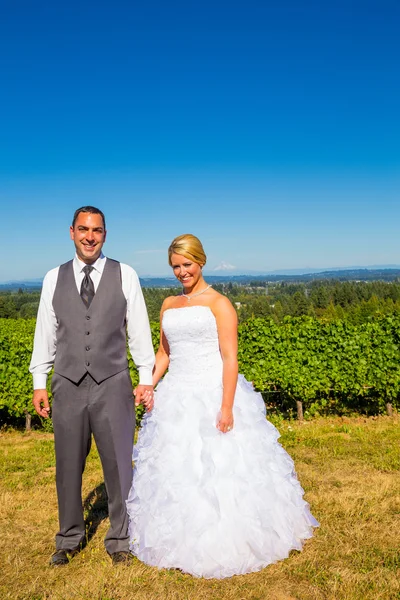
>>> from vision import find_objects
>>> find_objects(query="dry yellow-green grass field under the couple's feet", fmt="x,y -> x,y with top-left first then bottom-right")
0,416 -> 400,600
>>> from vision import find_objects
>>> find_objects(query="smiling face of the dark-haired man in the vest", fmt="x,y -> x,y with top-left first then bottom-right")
69,213 -> 106,265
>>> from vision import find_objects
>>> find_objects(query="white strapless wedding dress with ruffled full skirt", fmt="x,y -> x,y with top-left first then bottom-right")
127,306 -> 318,579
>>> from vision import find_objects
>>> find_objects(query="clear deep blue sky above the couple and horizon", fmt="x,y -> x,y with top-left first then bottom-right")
0,0 -> 400,281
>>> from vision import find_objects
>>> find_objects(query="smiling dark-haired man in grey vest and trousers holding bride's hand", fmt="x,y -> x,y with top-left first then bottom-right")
30,206 -> 154,566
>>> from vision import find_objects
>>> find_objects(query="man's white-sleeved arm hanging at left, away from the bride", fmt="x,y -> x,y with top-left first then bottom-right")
29,269 -> 58,417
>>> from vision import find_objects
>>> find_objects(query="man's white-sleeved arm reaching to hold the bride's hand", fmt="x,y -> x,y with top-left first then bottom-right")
121,264 -> 155,404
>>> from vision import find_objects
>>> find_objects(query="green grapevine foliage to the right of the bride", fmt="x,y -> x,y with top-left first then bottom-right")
239,317 -> 400,417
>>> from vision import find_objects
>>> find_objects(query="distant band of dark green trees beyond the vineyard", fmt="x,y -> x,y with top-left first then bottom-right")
0,279 -> 400,325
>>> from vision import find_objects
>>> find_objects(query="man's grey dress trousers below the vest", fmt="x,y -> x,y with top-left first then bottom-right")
52,369 -> 135,554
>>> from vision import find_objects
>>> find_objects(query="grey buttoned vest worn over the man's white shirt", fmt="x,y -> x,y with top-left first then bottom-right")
53,258 -> 128,383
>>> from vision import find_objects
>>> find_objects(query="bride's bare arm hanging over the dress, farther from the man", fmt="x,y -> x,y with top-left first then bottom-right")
212,296 -> 238,433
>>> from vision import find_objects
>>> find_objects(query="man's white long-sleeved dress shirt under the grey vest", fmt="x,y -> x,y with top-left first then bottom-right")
29,254 -> 154,390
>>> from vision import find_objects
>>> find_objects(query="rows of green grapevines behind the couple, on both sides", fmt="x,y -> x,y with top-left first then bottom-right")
0,316 -> 400,424
